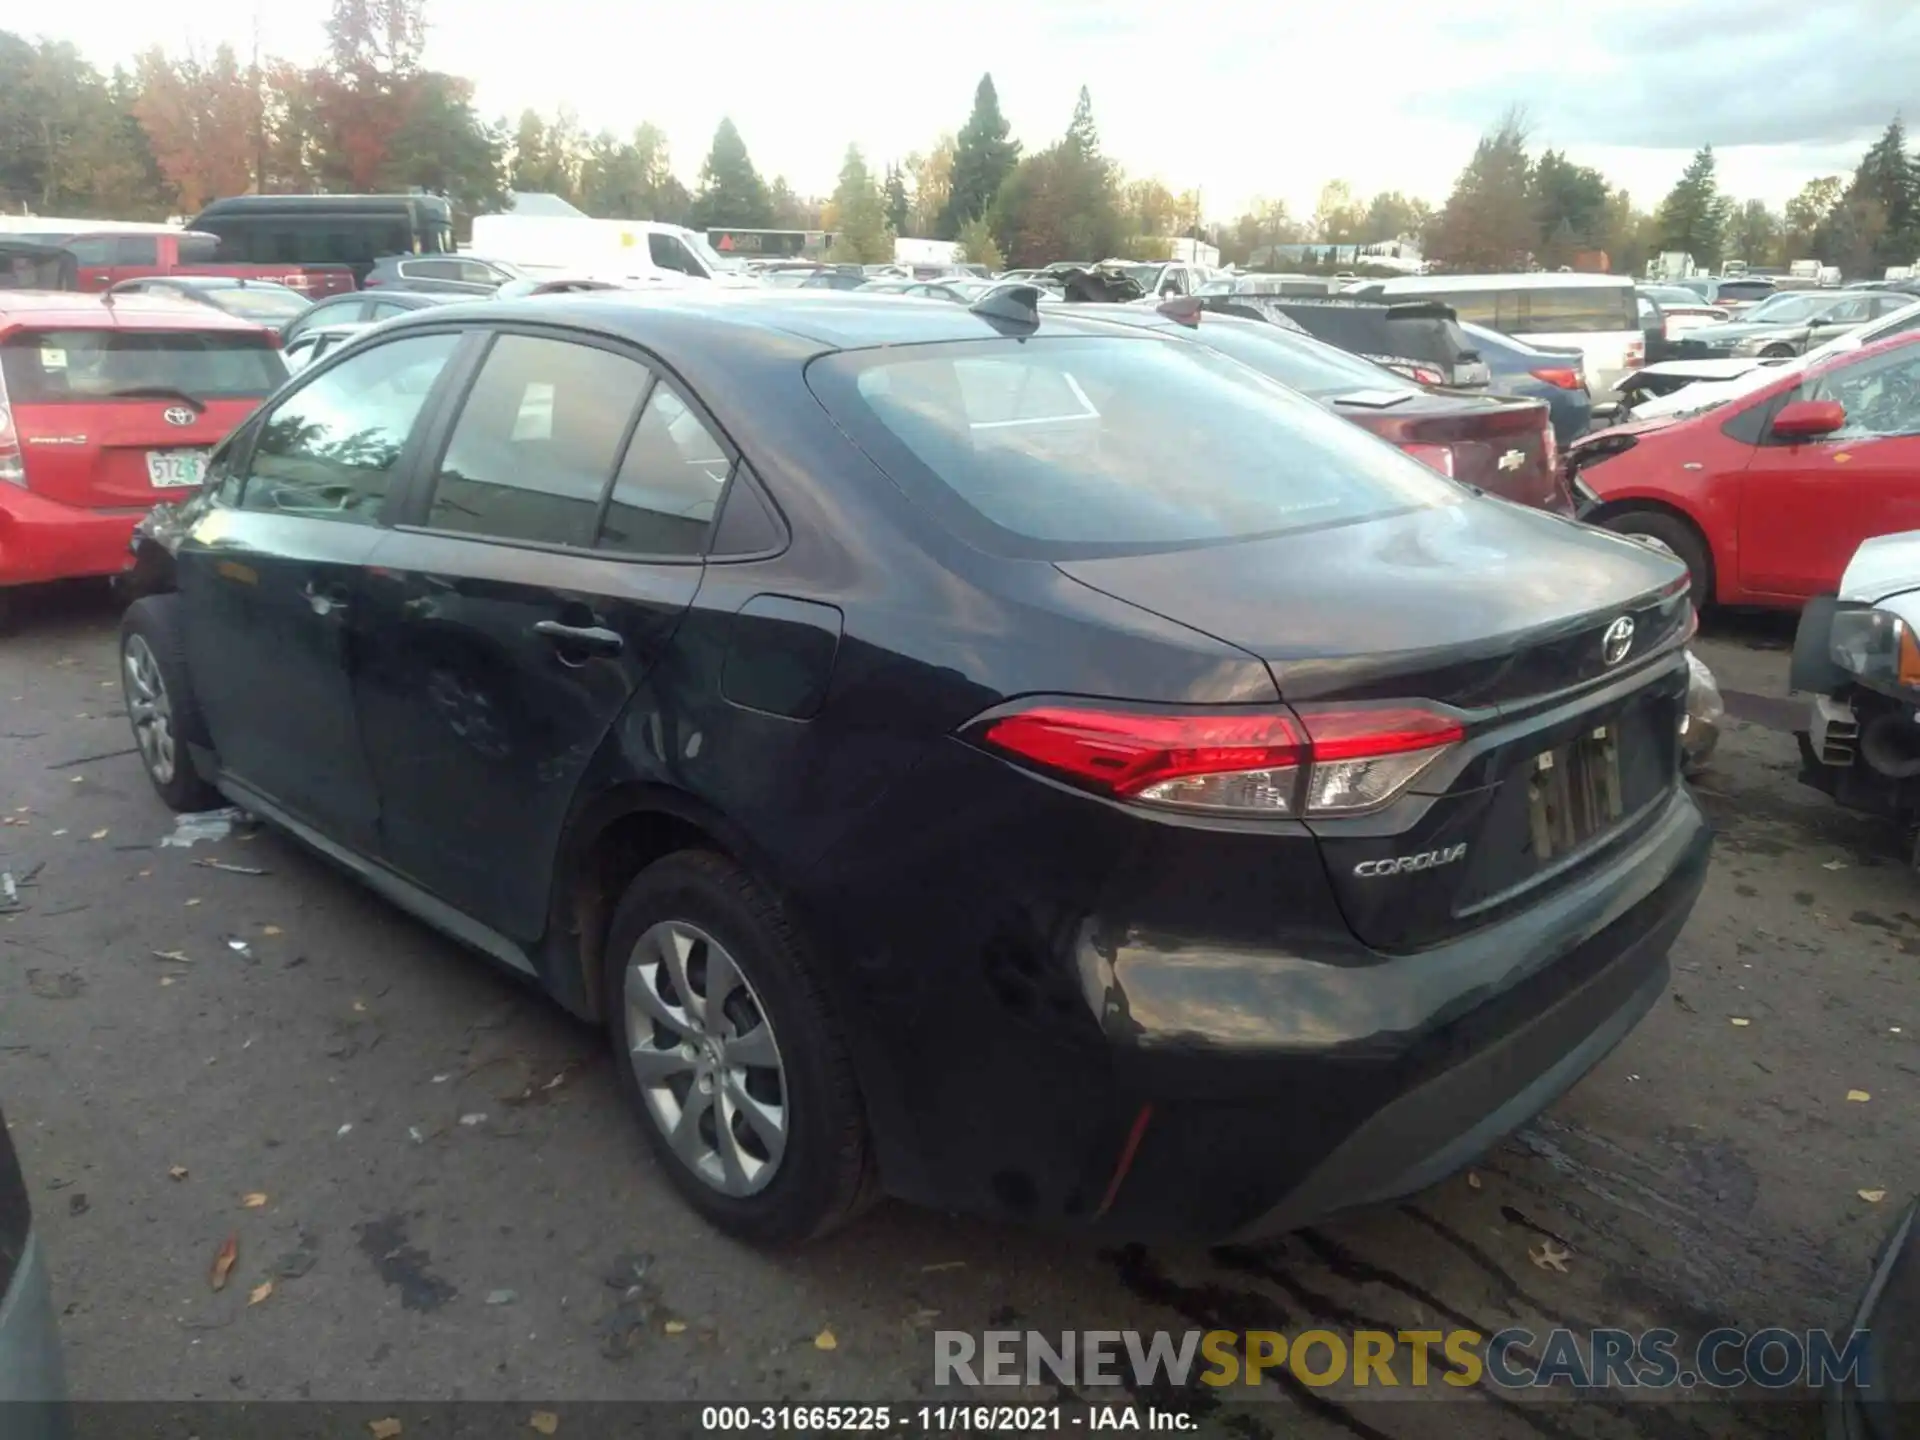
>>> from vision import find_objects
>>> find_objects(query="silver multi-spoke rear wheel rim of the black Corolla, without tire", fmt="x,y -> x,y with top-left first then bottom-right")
624,920 -> 787,1196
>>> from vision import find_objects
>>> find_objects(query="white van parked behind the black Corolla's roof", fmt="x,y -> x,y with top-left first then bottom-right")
472,215 -> 745,284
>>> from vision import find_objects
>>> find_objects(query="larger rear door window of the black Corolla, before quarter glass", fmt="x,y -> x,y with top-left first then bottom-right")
426,334 -> 651,547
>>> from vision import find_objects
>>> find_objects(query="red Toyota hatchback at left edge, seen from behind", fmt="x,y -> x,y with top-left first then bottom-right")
0,290 -> 286,622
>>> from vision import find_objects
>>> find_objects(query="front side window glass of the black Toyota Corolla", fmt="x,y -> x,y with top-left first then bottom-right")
240,334 -> 461,524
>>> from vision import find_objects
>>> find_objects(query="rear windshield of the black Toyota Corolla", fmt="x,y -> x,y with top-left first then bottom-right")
806,336 -> 1463,559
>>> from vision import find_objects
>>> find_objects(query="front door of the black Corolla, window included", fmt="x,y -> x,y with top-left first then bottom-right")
179,332 -> 459,852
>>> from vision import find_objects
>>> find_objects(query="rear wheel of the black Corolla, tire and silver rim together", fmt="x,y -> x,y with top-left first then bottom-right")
603,851 -> 876,1244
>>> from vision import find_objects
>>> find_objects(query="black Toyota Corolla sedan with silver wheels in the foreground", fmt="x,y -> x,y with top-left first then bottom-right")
121,292 -> 1709,1240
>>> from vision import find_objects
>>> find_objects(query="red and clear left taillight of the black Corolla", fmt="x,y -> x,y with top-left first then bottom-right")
970,705 -> 1465,818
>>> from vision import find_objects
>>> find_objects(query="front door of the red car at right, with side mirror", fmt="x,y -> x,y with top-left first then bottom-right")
1740,344 -> 1920,597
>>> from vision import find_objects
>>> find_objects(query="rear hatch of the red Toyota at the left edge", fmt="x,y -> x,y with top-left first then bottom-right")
0,324 -> 286,511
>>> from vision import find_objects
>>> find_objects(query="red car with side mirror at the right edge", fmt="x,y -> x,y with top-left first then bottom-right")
1569,334 -> 1920,609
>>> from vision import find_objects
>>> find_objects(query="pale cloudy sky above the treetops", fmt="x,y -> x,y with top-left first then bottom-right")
36,0 -> 1920,219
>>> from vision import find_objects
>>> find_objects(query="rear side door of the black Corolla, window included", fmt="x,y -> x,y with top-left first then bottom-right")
357,332 -> 714,943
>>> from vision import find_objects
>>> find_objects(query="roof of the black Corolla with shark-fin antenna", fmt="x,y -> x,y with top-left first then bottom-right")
392,286 -> 1167,349
